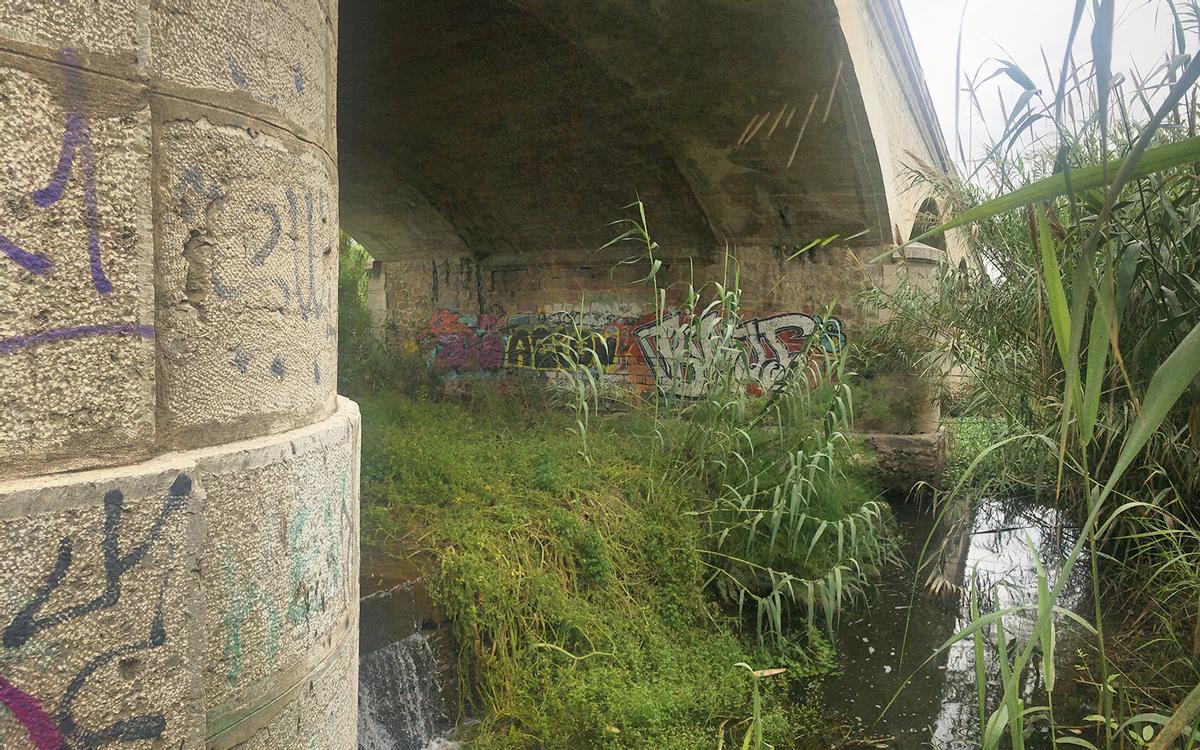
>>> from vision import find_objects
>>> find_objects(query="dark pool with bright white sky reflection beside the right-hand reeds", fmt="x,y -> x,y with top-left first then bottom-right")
827,500 -> 1091,750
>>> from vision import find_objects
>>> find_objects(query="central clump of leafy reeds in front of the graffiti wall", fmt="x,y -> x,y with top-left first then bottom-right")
568,202 -> 894,647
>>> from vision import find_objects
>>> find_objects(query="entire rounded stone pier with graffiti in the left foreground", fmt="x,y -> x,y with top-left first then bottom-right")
0,0 -> 359,750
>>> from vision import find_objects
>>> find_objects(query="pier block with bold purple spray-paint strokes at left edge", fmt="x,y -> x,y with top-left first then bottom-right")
0,58 -> 155,478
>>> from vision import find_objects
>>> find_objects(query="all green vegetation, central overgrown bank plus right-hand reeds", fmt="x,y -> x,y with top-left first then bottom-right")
343,10 -> 1200,750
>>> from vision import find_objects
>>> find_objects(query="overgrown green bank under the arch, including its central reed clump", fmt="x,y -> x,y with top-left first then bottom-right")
341,226 -> 893,750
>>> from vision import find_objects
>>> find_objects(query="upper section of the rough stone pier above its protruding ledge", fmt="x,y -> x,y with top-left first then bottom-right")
0,0 -> 338,476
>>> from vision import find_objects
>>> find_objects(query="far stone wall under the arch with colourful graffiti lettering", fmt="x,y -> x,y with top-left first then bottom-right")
380,247 -> 871,392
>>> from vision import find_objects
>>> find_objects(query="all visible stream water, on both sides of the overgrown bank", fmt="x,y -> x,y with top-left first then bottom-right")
359,502 -> 1113,750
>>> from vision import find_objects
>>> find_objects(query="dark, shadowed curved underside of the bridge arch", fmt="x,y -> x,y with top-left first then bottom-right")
338,0 -> 890,263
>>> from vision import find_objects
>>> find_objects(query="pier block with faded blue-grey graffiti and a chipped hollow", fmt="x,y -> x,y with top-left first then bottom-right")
155,113 -> 337,446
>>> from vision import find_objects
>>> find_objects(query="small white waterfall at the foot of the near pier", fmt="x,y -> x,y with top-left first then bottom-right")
359,632 -> 457,750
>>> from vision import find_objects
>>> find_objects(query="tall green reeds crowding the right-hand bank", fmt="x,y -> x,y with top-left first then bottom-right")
871,7 -> 1200,748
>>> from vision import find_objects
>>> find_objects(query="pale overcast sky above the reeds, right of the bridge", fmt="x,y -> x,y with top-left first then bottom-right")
901,0 -> 1172,157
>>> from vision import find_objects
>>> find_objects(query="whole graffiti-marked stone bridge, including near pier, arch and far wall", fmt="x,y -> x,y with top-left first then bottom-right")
0,0 -> 947,750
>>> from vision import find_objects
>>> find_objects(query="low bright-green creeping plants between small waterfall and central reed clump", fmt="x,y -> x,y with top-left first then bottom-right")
361,395 -> 832,750
